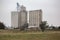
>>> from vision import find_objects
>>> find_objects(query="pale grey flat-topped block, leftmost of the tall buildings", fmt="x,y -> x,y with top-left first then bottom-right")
11,11 -> 18,28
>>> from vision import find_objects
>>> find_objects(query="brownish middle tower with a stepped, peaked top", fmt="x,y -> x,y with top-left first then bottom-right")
18,5 -> 27,27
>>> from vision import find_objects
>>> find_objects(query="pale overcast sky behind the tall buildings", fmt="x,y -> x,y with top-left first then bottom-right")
0,0 -> 60,26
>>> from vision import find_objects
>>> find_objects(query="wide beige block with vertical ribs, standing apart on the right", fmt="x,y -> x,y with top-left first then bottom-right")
29,10 -> 42,27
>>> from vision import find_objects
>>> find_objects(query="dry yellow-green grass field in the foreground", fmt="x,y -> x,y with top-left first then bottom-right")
0,30 -> 60,40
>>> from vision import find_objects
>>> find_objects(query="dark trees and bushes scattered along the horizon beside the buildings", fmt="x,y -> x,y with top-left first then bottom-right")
0,21 -> 60,32
